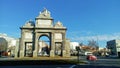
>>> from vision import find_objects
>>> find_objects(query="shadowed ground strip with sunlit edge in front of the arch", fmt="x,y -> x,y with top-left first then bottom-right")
0,57 -> 86,65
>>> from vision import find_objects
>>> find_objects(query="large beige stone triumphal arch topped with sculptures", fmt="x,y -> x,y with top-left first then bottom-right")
17,9 -> 70,57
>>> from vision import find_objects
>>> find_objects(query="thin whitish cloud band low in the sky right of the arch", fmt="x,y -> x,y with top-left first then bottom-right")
71,33 -> 120,41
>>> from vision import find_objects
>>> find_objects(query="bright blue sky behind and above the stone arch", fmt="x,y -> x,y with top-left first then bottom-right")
0,0 -> 120,47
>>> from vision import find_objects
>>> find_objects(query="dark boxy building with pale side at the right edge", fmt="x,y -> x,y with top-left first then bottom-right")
107,40 -> 120,57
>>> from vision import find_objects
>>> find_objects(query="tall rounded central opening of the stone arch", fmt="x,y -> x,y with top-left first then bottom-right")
38,35 -> 51,56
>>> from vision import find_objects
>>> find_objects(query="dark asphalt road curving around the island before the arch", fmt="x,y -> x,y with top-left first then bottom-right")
0,56 -> 120,68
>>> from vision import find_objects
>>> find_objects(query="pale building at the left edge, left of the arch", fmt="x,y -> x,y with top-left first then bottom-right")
0,33 -> 19,56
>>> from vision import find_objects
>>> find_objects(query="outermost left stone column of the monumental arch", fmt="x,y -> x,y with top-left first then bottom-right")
20,30 -> 25,58
